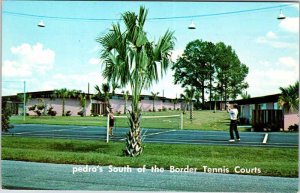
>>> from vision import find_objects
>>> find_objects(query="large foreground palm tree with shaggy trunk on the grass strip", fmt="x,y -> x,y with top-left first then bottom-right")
97,7 -> 174,156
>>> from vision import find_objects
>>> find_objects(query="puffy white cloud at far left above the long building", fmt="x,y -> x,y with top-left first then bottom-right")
2,43 -> 55,77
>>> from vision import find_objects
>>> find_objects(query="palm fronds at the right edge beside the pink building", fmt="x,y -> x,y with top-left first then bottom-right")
278,81 -> 299,113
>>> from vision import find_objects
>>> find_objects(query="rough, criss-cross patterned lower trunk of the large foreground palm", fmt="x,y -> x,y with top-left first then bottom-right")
124,111 -> 143,157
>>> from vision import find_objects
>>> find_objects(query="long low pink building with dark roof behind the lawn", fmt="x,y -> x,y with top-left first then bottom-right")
2,90 -> 184,116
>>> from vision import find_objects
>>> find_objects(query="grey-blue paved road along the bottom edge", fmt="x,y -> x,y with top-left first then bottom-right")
2,160 -> 298,193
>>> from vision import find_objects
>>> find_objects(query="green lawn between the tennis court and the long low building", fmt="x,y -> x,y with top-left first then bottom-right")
11,111 -> 238,131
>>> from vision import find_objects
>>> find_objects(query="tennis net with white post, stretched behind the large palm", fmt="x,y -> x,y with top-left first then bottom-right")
106,114 -> 183,142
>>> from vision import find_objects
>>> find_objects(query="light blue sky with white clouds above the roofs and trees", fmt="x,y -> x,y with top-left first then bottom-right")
2,1 -> 299,98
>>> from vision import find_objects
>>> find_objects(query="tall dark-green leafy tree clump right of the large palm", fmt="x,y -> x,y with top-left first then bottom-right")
171,40 -> 249,108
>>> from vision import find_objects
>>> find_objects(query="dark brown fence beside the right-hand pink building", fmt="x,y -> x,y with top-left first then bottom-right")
252,110 -> 284,131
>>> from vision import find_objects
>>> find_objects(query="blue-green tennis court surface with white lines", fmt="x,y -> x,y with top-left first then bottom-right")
2,124 -> 298,148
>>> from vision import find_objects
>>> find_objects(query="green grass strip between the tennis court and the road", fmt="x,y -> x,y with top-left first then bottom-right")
2,136 -> 298,177
